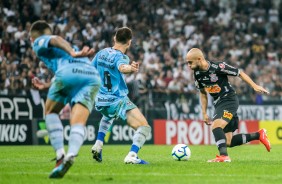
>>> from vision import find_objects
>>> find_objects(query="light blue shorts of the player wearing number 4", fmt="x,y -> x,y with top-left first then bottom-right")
95,96 -> 137,121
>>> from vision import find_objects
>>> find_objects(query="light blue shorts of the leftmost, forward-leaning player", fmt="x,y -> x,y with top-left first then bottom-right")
47,64 -> 101,112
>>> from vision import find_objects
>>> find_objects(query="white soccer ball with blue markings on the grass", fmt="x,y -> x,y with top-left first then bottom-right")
171,144 -> 191,161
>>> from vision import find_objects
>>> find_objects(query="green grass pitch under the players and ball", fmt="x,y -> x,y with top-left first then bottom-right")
0,145 -> 282,184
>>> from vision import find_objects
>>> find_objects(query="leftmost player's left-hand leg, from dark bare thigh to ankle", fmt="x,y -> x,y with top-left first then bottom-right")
45,98 -> 65,167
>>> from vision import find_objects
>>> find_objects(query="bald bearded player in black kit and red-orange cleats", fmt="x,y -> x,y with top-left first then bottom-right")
186,48 -> 271,162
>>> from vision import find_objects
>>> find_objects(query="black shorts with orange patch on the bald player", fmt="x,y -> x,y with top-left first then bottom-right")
212,93 -> 239,133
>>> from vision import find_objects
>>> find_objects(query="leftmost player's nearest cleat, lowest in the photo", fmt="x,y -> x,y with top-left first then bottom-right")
49,156 -> 74,179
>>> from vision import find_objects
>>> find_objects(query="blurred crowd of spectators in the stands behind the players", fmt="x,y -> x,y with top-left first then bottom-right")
0,0 -> 282,108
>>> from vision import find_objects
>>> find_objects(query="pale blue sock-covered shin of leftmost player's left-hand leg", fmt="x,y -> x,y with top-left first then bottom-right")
45,113 -> 65,160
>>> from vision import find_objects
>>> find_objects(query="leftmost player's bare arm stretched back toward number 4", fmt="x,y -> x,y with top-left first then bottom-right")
49,36 -> 94,57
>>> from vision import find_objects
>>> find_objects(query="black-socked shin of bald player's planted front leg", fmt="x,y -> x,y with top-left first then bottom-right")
212,127 -> 228,156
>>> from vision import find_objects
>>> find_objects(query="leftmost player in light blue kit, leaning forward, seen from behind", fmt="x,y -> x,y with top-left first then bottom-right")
30,20 -> 101,178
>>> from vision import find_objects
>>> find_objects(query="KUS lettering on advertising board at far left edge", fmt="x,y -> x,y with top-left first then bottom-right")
0,124 -> 28,142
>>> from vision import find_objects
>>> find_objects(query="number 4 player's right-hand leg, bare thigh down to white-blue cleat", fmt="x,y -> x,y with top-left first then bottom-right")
124,107 -> 151,164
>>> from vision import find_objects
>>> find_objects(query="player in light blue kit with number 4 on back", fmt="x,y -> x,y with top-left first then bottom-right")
92,27 -> 151,164
